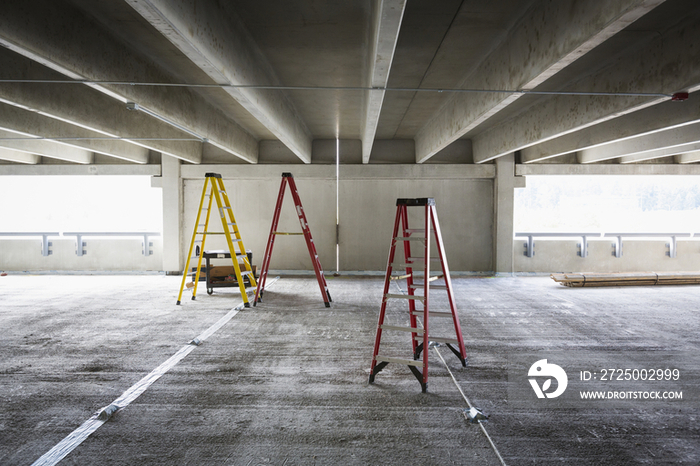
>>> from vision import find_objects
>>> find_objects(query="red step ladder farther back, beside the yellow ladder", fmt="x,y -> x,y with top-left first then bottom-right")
253,173 -> 333,307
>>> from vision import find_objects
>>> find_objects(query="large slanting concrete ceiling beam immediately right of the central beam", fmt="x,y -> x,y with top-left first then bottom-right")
416,0 -> 663,163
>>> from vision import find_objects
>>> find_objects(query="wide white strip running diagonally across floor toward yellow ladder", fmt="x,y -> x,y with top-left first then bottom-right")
32,277 -> 279,466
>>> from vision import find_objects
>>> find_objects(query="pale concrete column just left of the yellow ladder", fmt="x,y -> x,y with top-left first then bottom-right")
161,154 -> 185,275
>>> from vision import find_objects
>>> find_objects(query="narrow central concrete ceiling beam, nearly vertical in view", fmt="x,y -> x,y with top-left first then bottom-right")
360,0 -> 406,163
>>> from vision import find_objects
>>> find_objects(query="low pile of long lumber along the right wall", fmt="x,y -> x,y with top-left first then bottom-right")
551,272 -> 700,287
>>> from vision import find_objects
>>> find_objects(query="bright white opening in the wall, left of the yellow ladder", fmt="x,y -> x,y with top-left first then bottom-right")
0,175 -> 163,232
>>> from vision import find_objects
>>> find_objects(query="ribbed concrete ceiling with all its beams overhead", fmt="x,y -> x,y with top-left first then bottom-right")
0,0 -> 700,164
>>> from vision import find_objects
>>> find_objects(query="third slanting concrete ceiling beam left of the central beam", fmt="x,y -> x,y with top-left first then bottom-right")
0,47 -> 202,163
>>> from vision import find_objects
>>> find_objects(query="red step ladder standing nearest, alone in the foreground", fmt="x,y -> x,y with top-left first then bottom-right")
369,198 -> 467,393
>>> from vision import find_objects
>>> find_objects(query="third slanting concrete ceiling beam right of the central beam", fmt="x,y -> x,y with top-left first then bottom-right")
520,98 -> 700,163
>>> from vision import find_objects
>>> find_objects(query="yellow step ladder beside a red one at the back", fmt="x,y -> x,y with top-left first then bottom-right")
177,173 -> 257,307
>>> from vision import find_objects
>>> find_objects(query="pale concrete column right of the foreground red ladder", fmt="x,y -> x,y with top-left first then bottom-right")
493,154 -> 525,275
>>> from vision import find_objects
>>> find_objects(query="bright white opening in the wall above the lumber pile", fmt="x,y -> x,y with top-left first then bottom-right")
514,175 -> 700,234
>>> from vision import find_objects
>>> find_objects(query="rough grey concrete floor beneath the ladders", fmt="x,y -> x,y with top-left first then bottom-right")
0,275 -> 700,466
